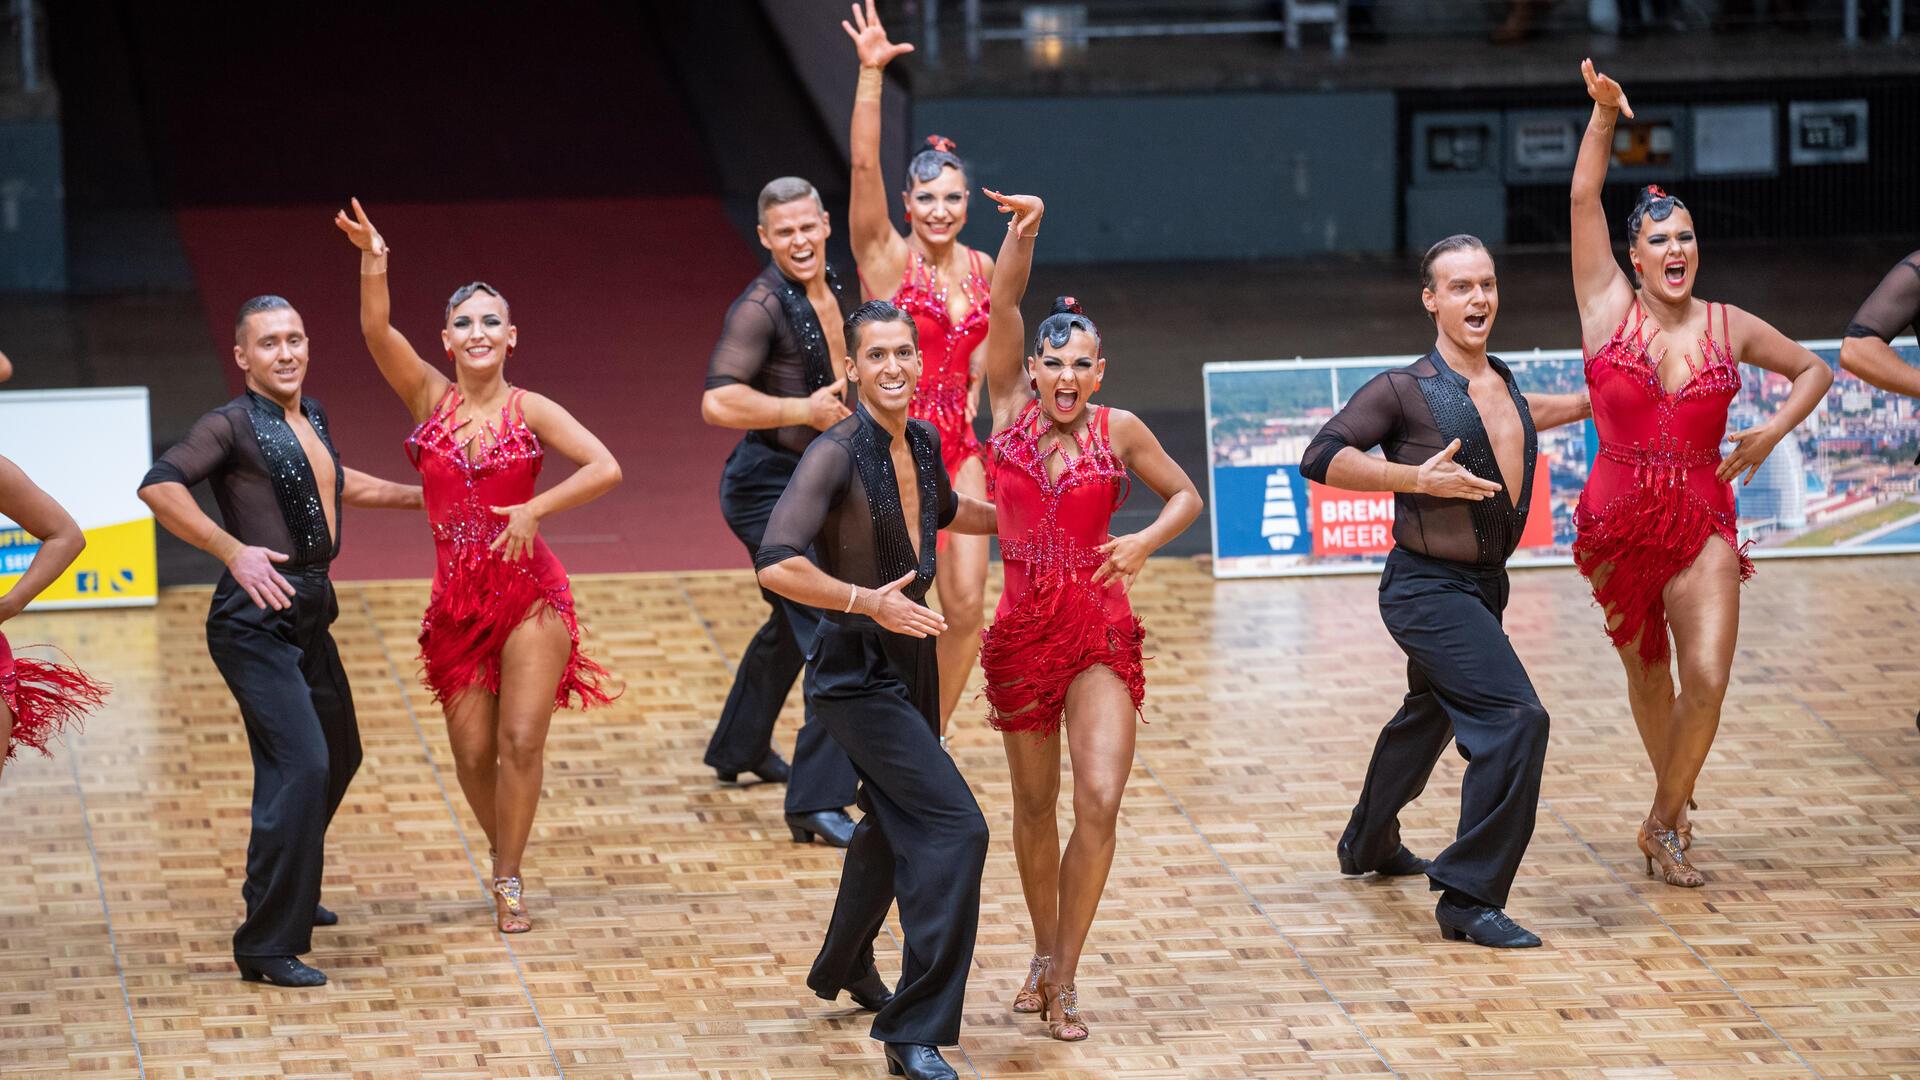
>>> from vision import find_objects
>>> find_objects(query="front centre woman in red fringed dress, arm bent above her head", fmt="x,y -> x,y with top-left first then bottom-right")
979,192 -> 1200,1042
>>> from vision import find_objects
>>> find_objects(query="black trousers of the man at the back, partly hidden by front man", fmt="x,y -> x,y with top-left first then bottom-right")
705,438 -> 854,813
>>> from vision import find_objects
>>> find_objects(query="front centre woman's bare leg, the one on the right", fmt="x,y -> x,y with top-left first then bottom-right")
1046,667 -> 1139,986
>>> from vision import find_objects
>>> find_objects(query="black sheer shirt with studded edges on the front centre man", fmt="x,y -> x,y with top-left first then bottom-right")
753,405 -> 960,607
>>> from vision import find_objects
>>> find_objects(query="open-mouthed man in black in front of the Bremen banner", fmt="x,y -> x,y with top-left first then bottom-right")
1300,236 -> 1588,949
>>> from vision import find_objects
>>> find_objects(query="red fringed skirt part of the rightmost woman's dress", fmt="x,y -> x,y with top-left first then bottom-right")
1572,484 -> 1753,665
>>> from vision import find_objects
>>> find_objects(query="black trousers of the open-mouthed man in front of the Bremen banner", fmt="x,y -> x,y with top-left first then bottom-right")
1342,548 -> 1548,907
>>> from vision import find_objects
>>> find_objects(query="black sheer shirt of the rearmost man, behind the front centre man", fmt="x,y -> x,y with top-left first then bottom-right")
707,263 -> 852,451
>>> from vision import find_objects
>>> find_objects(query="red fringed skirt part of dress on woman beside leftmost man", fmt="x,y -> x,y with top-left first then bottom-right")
420,544 -> 612,709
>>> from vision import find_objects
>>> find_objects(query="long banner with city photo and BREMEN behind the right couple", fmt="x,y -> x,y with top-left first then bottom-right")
1204,338 -> 1920,577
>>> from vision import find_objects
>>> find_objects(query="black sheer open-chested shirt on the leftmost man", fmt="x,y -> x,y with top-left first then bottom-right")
140,390 -> 346,569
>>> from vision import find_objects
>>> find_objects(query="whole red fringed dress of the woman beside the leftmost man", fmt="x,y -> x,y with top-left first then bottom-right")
407,386 -> 611,709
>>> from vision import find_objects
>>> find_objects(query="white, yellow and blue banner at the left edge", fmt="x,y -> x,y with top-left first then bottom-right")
0,386 -> 159,609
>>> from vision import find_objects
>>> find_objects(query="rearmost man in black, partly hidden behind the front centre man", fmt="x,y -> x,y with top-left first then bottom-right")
701,177 -> 854,847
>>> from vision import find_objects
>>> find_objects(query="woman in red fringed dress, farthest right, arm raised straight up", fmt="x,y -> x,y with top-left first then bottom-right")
1572,60 -> 1834,888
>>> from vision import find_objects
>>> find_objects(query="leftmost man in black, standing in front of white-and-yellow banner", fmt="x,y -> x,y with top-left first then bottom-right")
140,296 -> 420,986
